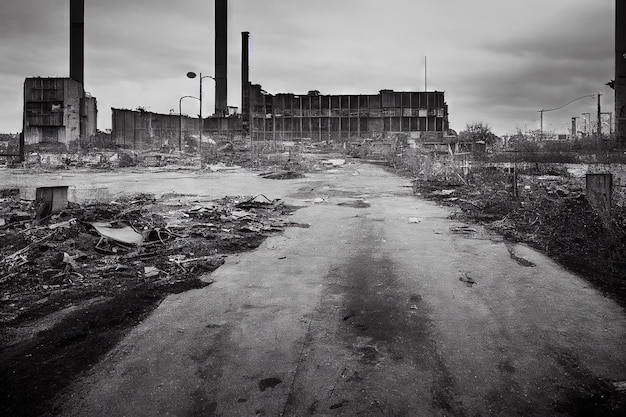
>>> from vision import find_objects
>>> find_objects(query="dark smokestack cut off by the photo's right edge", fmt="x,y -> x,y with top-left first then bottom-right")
614,0 -> 626,142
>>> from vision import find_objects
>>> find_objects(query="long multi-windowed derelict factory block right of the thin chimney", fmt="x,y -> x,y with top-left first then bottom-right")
244,84 -> 449,141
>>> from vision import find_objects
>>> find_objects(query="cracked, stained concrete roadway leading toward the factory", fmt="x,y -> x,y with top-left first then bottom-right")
46,164 -> 626,417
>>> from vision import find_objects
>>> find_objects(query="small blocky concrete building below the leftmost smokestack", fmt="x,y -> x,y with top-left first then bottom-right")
23,77 -> 98,146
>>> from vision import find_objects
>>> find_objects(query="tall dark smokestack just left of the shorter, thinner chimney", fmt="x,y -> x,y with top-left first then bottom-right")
215,0 -> 228,116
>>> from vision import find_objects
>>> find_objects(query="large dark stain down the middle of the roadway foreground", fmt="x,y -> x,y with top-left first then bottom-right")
328,247 -> 464,416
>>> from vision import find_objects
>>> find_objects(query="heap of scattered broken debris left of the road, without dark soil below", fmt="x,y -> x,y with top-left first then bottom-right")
0,194 -> 294,324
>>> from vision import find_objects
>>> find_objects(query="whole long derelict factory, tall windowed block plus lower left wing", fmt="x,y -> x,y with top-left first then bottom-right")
112,88 -> 449,150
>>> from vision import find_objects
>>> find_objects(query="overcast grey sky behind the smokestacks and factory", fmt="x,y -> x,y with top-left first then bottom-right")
0,0 -> 615,134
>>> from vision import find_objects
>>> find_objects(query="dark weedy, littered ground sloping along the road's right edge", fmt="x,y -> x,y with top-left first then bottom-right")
414,170 -> 626,308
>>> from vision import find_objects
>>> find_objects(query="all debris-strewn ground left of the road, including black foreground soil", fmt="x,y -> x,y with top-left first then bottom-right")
0,183 -> 302,416
